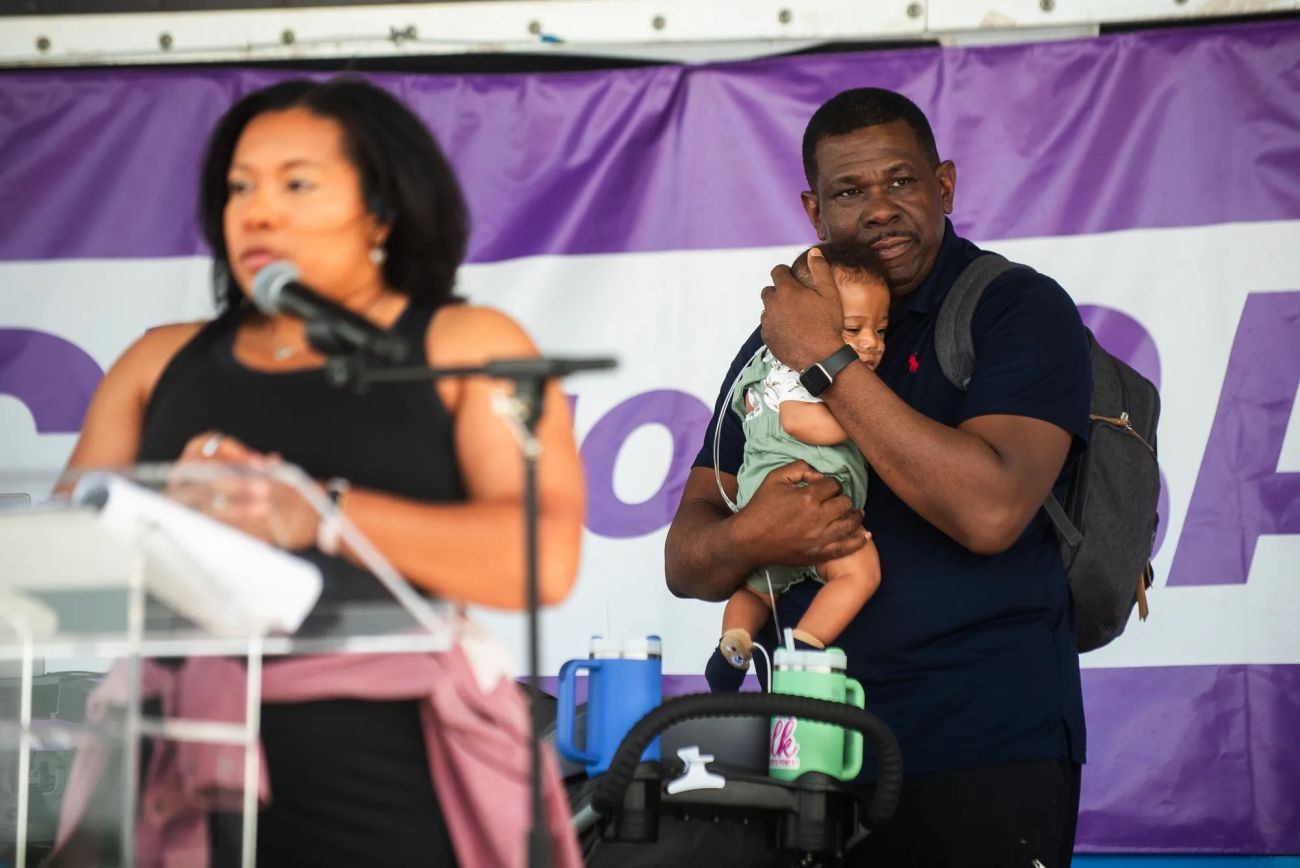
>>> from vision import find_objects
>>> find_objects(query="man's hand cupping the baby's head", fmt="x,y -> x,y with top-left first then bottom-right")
762,245 -> 844,370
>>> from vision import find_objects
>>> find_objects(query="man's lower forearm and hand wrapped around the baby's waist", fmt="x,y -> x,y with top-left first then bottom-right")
664,461 -> 868,600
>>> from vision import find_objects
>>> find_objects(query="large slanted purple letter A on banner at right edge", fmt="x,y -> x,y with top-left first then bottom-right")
1169,292 -> 1300,585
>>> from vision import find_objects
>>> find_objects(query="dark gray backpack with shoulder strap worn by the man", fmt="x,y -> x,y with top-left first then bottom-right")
935,253 -> 1160,651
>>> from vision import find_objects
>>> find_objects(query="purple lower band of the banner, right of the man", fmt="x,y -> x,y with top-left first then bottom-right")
1078,665 -> 1300,854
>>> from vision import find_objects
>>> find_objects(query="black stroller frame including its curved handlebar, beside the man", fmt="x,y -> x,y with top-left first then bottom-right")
559,693 -> 902,868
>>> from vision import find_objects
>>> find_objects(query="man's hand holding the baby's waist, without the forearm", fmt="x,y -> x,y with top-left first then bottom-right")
736,461 -> 870,567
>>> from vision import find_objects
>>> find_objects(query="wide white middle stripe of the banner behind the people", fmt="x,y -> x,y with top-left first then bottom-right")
0,215 -> 1300,673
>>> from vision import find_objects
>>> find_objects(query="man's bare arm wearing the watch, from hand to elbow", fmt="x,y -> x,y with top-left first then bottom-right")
763,249 -> 1070,555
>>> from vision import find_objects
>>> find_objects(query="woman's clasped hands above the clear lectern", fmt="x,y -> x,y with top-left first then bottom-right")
166,431 -> 320,551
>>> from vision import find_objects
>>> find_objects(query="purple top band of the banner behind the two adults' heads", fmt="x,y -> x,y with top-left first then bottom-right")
0,16 -> 1300,261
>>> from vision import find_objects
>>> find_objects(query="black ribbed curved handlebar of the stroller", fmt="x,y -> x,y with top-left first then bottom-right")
592,693 -> 902,823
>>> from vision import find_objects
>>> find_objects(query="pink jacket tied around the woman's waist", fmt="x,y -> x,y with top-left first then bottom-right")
56,623 -> 582,868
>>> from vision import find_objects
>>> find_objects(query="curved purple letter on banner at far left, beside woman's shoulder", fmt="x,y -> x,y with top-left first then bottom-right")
0,329 -> 104,434
